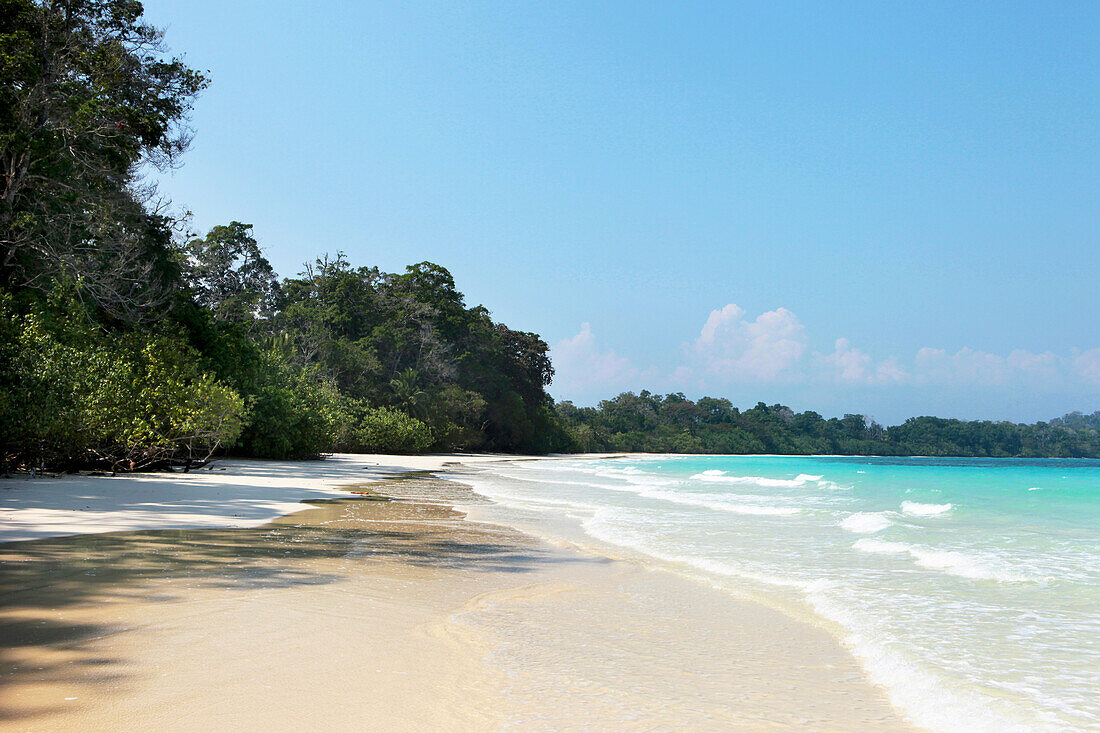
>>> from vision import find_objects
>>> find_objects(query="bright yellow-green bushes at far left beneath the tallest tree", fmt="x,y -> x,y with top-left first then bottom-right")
0,291 -> 244,470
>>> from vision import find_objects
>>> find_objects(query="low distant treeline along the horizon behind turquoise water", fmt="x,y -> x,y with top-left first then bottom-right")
557,391 -> 1100,458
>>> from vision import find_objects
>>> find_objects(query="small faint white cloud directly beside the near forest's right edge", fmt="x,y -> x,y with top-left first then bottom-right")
550,322 -> 652,397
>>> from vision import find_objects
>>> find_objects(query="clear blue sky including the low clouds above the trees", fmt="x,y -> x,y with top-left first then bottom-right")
145,0 -> 1100,422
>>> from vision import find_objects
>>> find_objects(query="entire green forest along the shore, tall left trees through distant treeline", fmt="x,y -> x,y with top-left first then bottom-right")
0,0 -> 1100,471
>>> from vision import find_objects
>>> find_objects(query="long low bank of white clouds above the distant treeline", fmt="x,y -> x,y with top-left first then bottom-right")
551,303 -> 1100,398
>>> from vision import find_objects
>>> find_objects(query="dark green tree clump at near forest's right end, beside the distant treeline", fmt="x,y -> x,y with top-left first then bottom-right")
273,254 -> 568,451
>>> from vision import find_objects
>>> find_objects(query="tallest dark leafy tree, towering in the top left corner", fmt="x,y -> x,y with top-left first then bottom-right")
0,0 -> 206,321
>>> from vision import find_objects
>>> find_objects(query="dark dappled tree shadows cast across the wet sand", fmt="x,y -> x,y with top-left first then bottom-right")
0,472 -> 602,720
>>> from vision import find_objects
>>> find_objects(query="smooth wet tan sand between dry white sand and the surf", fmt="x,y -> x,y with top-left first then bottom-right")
0,474 -> 909,731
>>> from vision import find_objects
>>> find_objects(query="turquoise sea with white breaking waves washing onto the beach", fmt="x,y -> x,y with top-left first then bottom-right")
463,456 -> 1100,731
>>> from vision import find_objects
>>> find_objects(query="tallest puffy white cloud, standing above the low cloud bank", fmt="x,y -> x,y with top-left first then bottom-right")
688,303 -> 806,381
